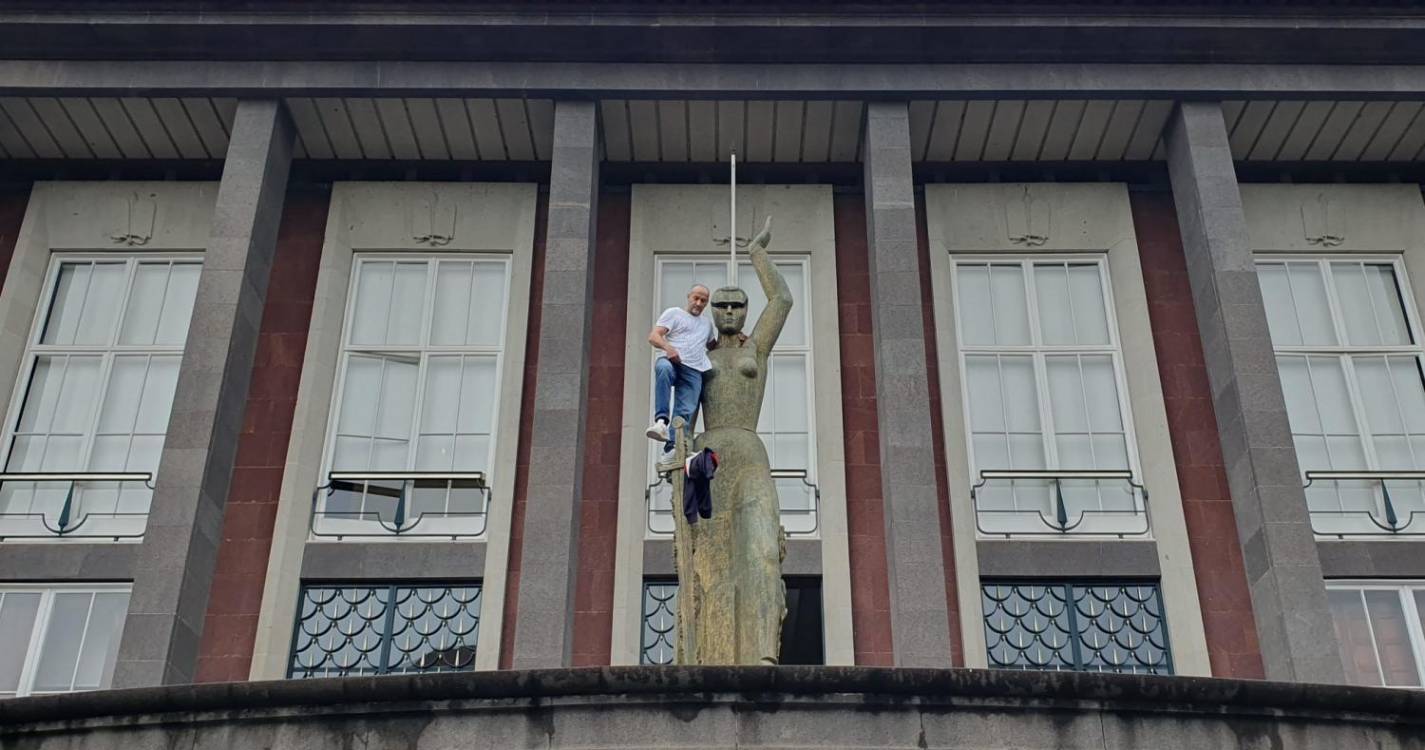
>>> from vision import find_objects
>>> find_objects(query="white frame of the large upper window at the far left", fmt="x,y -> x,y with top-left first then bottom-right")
0,252 -> 204,543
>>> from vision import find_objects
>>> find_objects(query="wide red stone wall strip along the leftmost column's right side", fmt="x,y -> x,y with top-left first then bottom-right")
194,192 -> 329,682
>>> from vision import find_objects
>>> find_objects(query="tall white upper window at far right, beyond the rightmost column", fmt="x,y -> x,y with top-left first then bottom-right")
1257,258 -> 1425,533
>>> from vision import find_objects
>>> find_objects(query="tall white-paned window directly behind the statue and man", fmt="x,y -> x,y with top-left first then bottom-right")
648,257 -> 817,533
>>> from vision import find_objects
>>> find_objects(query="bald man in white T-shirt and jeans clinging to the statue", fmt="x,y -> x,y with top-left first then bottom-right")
647,284 -> 717,461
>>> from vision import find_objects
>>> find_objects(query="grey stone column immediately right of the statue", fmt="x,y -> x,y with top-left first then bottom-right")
865,103 -> 950,667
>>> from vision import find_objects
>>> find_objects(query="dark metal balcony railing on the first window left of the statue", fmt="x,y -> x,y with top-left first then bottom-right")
309,472 -> 490,540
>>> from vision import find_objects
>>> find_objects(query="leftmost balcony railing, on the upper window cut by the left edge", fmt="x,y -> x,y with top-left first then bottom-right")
0,472 -> 154,542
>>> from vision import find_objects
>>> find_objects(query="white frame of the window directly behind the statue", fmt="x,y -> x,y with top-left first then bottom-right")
644,252 -> 821,539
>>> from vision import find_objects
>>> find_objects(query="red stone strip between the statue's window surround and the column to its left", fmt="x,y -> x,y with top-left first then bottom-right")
573,192 -> 632,667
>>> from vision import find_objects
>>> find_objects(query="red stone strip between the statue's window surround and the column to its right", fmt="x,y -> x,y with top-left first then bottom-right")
832,195 -> 893,666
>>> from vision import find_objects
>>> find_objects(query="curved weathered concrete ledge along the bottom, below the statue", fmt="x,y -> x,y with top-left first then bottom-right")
0,667 -> 1425,750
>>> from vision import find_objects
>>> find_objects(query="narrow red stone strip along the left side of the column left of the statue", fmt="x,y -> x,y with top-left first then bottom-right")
498,191 -> 549,669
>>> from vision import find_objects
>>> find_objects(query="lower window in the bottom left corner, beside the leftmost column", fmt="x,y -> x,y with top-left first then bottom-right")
0,585 -> 128,697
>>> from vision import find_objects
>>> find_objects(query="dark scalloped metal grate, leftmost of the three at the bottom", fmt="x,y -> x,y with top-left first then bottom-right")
288,583 -> 480,677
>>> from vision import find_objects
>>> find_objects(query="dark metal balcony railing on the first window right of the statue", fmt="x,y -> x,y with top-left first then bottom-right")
970,469 -> 1150,539
